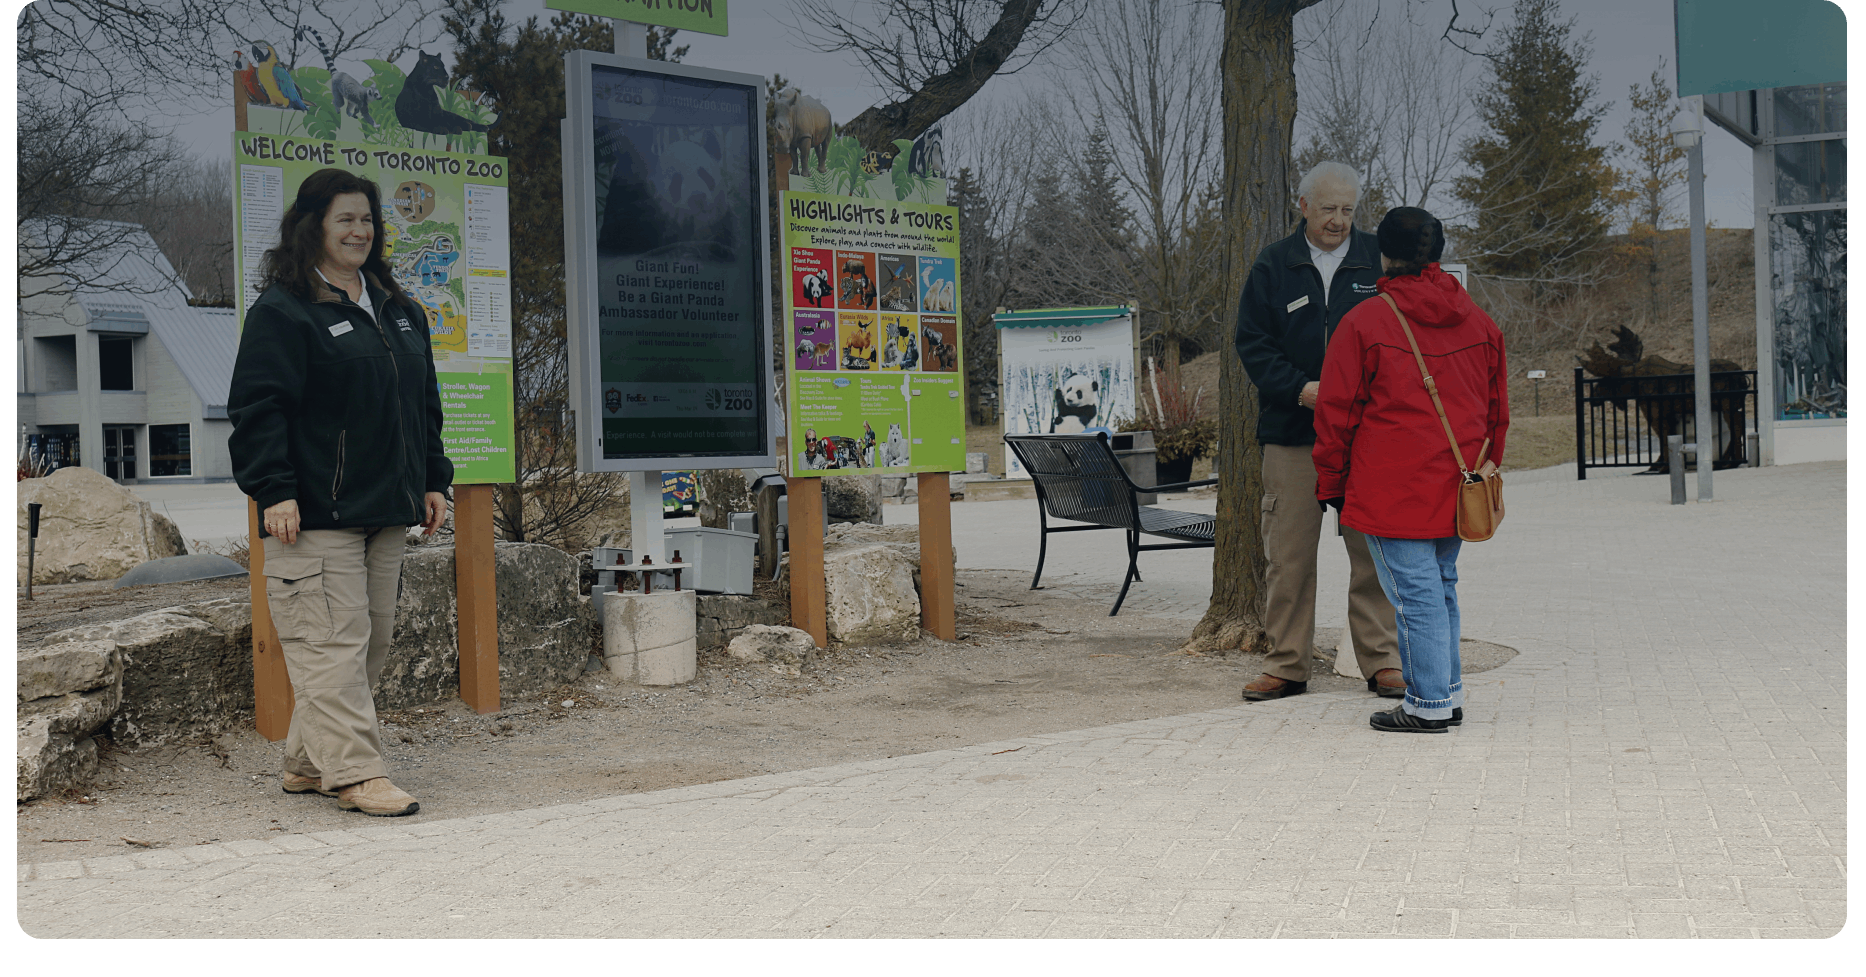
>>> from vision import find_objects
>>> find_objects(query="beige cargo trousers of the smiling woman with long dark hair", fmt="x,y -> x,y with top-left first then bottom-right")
265,526 -> 407,791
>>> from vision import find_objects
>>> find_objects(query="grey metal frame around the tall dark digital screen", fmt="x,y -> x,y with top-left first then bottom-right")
562,50 -> 778,472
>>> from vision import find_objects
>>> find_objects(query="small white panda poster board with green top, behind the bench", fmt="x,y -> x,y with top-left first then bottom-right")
995,306 -> 1135,477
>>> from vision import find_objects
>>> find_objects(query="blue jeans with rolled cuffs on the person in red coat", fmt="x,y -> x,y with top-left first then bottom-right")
1368,533 -> 1465,720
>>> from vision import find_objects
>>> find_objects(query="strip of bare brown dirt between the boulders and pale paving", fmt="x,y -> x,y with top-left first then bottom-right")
13,571 -> 1515,861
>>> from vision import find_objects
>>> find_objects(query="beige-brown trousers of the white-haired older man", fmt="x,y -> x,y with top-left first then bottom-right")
1263,444 -> 1400,682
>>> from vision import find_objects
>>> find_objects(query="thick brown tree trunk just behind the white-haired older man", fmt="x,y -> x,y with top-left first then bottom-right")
1185,0 -> 1316,654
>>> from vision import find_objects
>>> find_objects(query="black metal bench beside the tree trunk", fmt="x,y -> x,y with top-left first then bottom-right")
1004,434 -> 1218,617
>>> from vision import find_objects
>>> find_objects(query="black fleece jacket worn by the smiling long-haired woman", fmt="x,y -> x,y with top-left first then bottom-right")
228,278 -> 453,531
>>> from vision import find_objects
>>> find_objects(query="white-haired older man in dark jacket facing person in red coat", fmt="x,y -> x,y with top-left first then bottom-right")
1237,162 -> 1405,699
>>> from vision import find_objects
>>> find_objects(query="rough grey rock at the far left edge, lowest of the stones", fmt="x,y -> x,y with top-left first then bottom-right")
13,641 -> 123,802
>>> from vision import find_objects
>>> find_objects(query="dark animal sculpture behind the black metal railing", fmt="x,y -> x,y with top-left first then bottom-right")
1575,326 -> 1748,474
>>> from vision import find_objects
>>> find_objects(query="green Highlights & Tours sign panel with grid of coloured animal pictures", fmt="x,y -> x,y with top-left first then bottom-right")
778,194 -> 965,475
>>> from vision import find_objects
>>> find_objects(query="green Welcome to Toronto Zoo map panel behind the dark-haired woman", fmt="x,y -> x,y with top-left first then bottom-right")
233,132 -> 517,485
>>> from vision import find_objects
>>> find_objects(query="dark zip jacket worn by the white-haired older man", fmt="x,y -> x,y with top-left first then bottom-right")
1237,220 -> 1381,446
